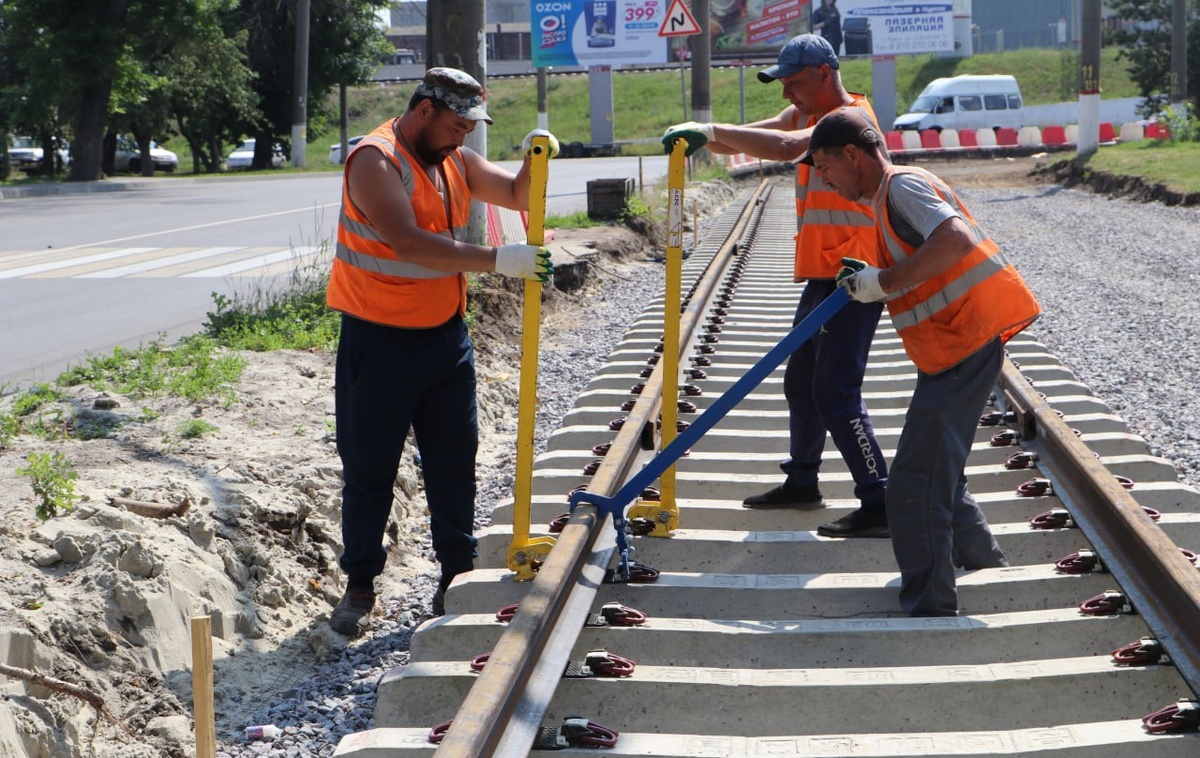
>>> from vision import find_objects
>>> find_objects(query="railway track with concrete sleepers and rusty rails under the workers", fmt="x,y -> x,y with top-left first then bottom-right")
335,178 -> 1200,758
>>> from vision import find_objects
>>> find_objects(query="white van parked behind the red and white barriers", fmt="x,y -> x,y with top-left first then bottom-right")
892,74 -> 1025,131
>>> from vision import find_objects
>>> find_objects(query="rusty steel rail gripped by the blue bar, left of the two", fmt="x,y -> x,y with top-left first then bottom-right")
434,181 -> 770,758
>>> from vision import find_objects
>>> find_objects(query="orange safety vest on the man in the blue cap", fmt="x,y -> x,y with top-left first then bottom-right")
793,92 -> 883,282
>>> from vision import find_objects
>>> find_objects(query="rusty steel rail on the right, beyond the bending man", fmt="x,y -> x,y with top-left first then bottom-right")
1000,359 -> 1200,694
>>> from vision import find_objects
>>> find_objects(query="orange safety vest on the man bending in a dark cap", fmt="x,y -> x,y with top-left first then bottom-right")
874,166 -> 1042,374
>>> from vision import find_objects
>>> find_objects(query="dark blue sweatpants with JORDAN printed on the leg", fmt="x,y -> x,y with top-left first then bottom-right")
780,279 -> 888,508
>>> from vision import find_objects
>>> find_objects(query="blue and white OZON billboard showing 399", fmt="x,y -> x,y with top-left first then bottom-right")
530,0 -> 670,68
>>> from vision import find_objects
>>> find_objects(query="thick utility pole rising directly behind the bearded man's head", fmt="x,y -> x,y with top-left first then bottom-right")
425,0 -> 487,245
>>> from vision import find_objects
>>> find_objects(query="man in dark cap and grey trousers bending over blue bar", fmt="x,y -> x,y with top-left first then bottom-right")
802,108 -> 1040,616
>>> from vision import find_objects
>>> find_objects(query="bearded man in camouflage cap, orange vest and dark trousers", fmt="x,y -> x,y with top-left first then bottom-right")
328,68 -> 558,636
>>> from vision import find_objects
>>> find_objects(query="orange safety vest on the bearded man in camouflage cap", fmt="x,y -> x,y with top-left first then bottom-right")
325,121 -> 470,329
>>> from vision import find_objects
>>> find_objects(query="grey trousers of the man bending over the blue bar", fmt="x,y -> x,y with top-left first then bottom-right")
886,338 -> 1008,616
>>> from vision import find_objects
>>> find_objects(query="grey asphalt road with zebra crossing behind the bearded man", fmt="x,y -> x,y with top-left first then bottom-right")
0,156 -> 666,391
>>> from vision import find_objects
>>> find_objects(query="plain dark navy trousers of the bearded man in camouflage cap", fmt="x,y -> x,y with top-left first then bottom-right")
334,314 -> 479,584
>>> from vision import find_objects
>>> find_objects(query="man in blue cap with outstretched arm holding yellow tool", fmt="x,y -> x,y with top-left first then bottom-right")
664,34 -> 888,537
